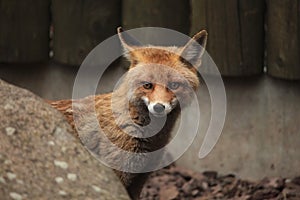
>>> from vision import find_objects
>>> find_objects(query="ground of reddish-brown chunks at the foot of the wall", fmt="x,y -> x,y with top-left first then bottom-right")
141,166 -> 300,200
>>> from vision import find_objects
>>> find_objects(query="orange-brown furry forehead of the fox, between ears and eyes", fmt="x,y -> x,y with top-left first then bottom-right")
128,46 -> 199,88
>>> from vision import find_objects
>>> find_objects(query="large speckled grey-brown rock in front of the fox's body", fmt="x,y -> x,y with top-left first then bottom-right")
0,80 -> 129,200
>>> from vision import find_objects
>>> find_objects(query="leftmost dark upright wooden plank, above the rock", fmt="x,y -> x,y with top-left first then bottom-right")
0,0 -> 50,63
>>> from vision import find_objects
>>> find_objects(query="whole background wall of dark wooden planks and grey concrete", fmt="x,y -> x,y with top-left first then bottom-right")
0,0 -> 300,179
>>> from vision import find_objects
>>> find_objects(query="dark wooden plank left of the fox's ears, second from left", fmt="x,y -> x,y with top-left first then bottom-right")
52,0 -> 121,65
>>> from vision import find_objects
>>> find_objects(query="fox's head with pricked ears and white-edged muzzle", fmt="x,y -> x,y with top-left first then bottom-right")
118,28 -> 207,117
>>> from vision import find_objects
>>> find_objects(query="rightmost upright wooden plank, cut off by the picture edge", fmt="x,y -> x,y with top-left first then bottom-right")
266,0 -> 300,80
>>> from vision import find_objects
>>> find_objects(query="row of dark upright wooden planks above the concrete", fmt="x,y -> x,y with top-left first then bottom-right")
0,0 -> 300,80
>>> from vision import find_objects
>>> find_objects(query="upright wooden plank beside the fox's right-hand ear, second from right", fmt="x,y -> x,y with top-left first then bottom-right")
191,0 -> 264,76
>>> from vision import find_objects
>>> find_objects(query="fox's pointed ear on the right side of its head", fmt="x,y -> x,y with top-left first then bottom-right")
180,30 -> 208,67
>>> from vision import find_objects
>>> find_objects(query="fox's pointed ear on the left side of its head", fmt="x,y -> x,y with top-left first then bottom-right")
117,27 -> 142,62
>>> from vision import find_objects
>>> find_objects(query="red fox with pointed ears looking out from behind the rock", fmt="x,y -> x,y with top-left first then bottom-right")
50,28 -> 207,199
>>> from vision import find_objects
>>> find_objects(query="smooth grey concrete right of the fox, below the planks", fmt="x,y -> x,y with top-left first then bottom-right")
177,76 -> 300,180
